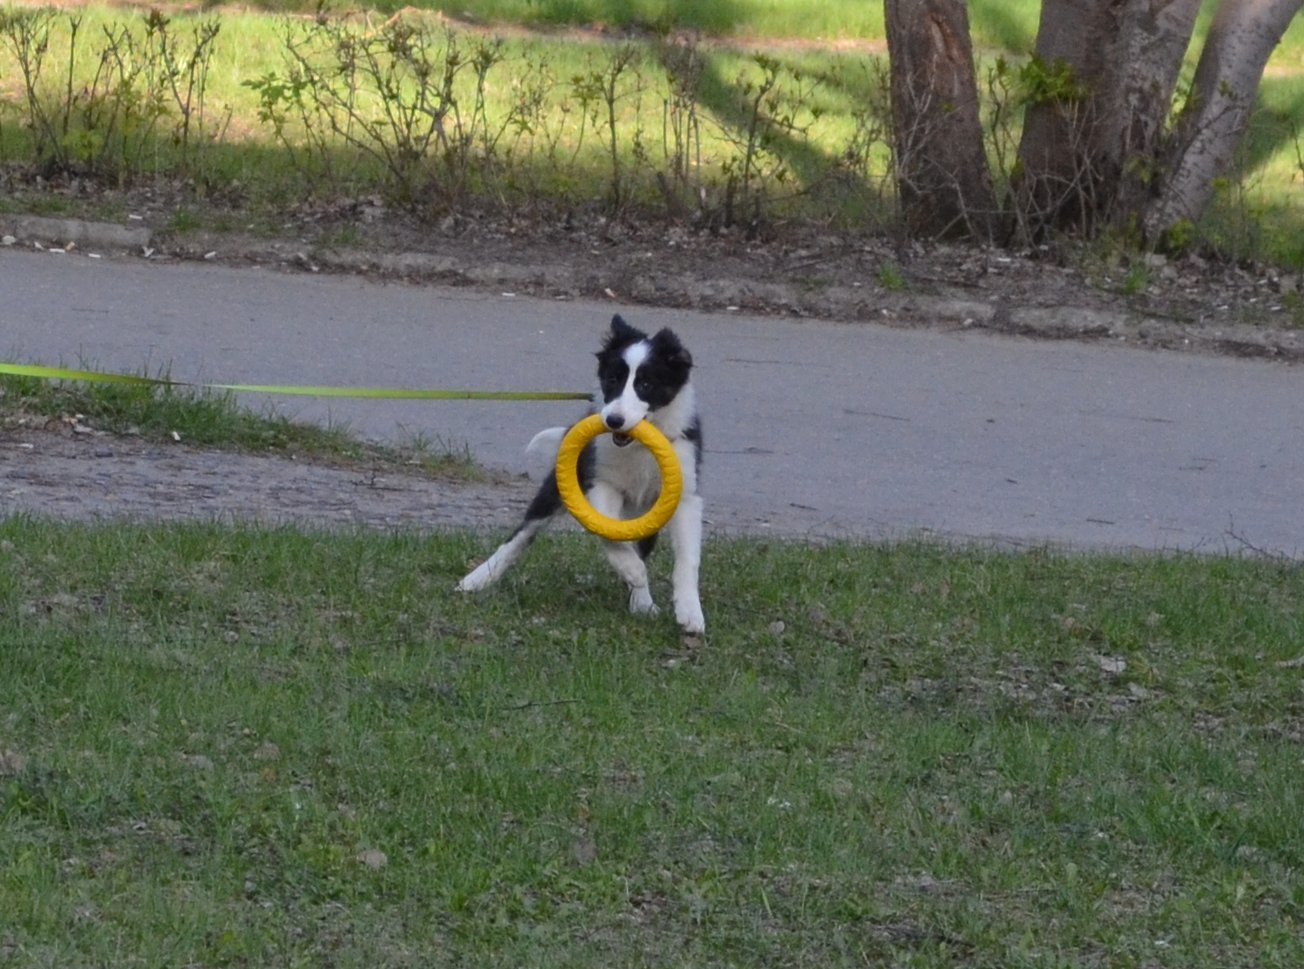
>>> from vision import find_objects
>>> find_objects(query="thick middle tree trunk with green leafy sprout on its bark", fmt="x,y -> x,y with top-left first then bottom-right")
1012,0 -> 1200,239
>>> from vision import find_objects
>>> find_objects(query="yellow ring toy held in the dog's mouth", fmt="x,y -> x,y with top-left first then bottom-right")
557,413 -> 683,541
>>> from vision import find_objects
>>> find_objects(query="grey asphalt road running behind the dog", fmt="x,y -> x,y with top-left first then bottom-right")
0,249 -> 1304,558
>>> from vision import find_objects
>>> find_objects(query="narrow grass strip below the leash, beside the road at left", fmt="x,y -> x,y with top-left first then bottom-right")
0,373 -> 482,480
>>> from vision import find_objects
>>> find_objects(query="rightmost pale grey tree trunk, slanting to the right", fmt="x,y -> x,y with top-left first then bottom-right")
1145,0 -> 1304,239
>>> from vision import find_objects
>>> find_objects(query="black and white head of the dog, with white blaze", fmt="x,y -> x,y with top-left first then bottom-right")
597,316 -> 692,446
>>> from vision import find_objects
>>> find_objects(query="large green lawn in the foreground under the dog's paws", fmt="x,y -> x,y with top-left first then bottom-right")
0,518 -> 1304,969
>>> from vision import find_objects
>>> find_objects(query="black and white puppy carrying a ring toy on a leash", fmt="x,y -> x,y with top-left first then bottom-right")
458,316 -> 707,634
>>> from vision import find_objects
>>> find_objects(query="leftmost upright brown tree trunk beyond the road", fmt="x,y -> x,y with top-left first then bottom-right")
884,0 -> 996,241
